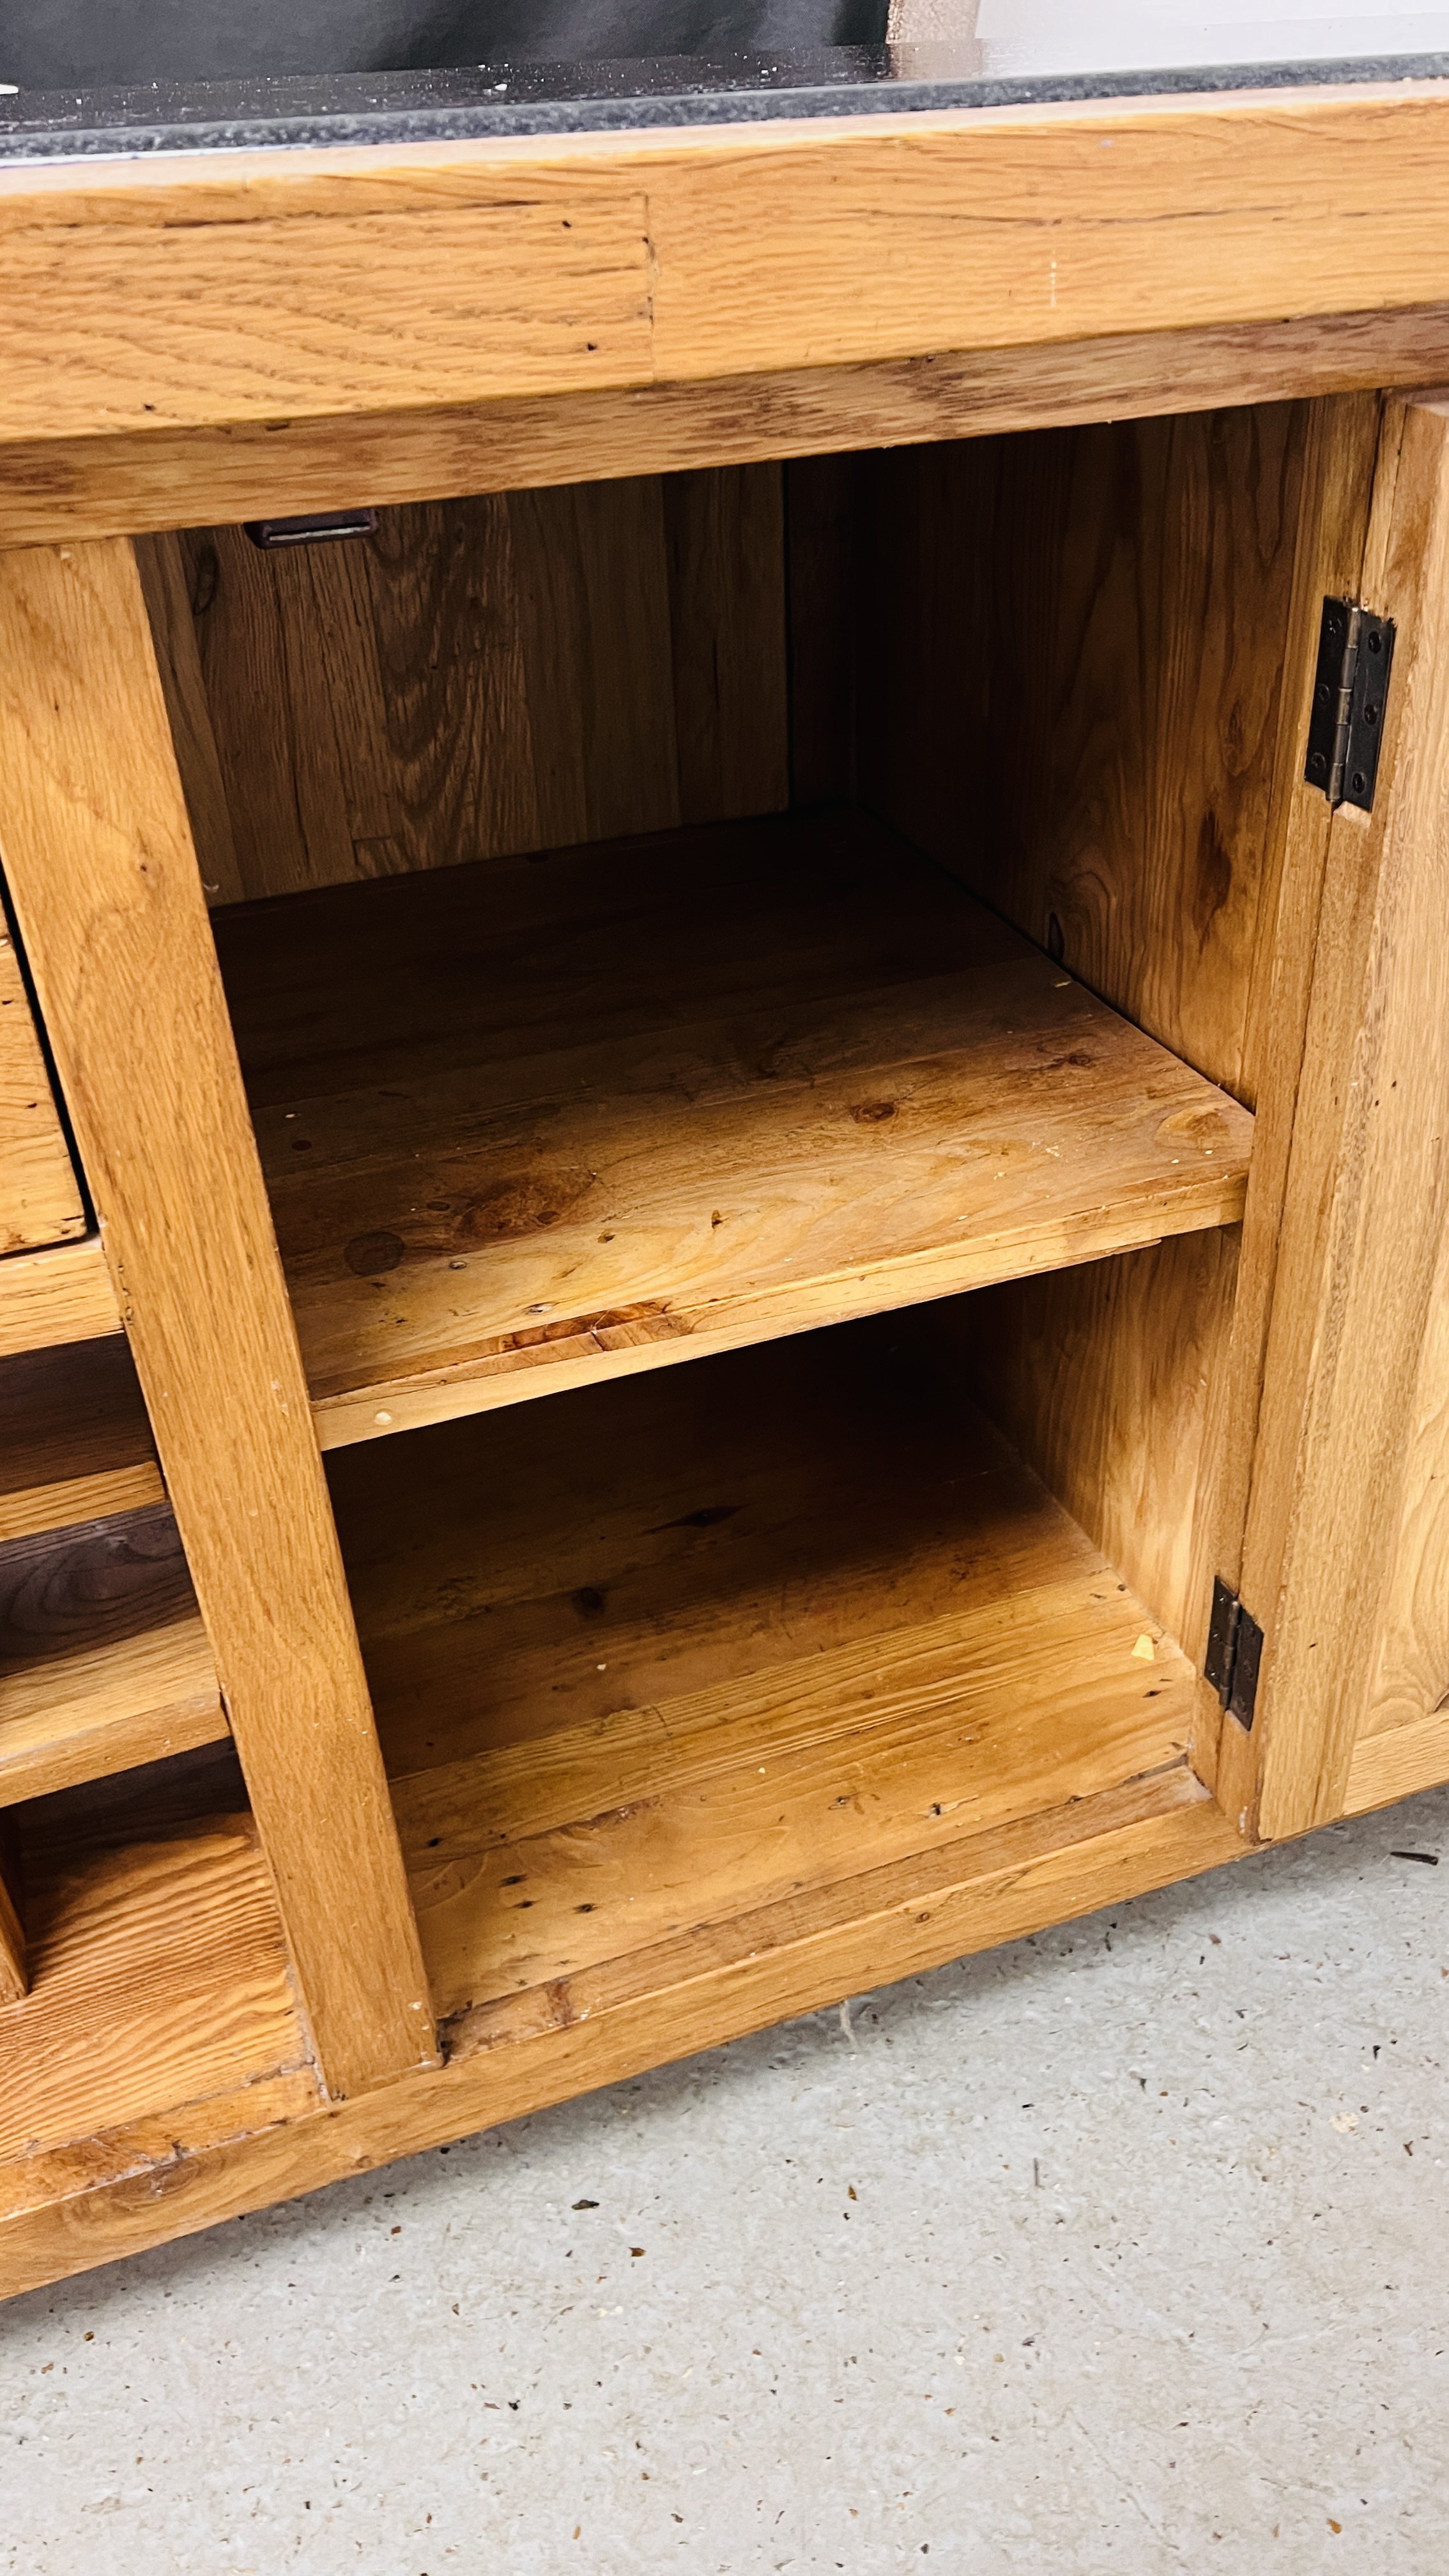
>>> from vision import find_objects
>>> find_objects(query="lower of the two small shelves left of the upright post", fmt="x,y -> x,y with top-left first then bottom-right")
0,1505 -> 227,1805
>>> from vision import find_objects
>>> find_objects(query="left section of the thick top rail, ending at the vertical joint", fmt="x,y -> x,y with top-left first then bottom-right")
0,172 -> 652,438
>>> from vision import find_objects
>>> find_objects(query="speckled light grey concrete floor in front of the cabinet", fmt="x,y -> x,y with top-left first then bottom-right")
0,1793 -> 1449,2576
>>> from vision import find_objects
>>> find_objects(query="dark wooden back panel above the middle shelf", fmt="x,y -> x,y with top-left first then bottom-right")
160,466 -> 789,901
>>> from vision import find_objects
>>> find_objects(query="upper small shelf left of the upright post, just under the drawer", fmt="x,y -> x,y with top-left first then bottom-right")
0,1335 -> 162,1543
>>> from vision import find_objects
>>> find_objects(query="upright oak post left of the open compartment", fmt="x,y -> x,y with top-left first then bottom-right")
0,544 -> 433,2092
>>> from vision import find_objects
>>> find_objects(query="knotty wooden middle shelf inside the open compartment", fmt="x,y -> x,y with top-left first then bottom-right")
217,811 -> 1253,1445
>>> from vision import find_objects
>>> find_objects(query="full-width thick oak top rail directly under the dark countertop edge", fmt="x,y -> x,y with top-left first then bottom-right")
11,82 -> 1449,440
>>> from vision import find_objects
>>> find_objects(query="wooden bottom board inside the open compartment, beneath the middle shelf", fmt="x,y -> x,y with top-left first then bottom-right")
330,1316 -> 1199,2048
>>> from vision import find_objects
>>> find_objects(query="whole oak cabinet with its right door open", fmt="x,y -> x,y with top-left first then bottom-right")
0,75 -> 1449,2287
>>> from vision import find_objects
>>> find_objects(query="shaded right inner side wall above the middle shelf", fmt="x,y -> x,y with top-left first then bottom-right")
859,404 -> 1305,1105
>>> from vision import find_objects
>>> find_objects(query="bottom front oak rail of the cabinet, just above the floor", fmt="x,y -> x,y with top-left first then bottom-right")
0,1770 -> 1245,2296
